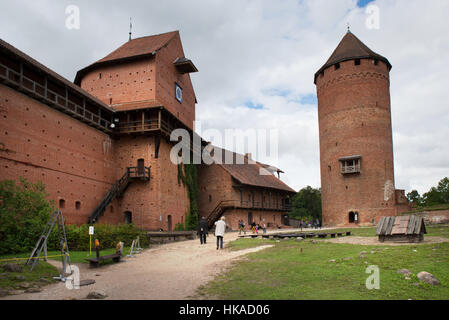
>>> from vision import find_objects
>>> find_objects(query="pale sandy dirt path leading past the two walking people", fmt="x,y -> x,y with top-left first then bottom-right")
3,233 -> 270,300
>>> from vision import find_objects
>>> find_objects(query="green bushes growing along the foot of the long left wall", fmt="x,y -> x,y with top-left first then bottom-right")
0,179 -> 148,254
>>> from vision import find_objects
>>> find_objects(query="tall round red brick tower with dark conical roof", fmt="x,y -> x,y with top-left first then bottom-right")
315,31 -> 396,226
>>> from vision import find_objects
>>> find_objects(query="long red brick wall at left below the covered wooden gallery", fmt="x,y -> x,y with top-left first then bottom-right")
0,84 -> 116,224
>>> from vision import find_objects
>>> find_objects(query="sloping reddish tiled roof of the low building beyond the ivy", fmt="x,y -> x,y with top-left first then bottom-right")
207,147 -> 296,193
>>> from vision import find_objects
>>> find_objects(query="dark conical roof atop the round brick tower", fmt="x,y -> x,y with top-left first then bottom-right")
315,30 -> 392,83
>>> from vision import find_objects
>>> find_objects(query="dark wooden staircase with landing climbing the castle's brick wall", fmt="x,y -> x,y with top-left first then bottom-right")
89,167 -> 150,224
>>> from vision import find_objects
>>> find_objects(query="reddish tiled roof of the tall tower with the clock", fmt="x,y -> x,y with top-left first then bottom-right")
74,31 -> 179,85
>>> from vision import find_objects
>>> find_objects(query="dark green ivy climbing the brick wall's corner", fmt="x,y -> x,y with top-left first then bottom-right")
176,164 -> 198,230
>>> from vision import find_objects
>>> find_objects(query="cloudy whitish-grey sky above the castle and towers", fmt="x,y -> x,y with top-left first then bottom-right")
0,0 -> 449,193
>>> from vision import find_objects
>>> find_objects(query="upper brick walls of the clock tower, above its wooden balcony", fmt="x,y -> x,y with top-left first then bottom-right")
77,34 -> 195,129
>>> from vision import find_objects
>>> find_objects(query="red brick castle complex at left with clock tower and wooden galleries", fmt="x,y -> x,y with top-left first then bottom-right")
0,31 -> 294,230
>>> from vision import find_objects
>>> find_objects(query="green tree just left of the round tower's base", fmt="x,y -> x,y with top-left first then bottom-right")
289,186 -> 321,221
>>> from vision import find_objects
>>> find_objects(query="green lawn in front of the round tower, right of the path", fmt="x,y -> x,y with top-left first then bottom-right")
198,227 -> 449,300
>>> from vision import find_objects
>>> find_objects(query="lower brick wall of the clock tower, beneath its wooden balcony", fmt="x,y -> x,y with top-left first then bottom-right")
113,136 -> 190,231
